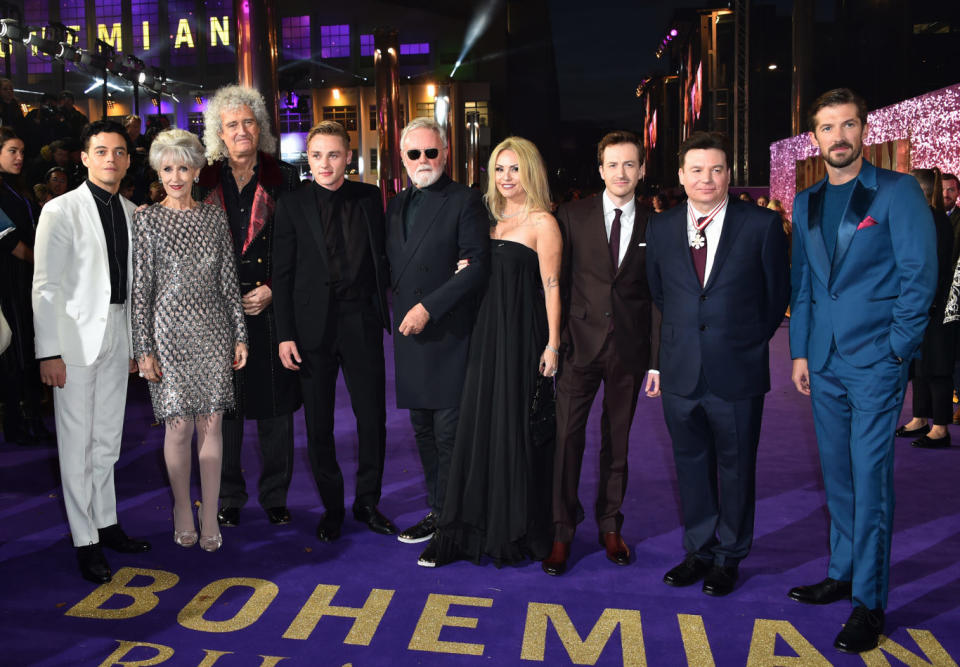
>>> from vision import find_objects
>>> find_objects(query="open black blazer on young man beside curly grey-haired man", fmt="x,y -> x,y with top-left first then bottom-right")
273,181 -> 390,349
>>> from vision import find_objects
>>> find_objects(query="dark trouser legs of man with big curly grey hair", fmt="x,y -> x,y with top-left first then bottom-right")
220,413 -> 293,509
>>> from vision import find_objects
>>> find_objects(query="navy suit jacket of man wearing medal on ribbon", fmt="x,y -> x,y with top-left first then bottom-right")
647,199 -> 790,401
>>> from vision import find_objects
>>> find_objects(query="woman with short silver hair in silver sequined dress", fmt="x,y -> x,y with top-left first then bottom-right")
132,130 -> 247,551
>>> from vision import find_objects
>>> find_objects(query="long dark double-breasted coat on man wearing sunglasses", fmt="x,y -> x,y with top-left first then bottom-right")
387,175 -> 490,410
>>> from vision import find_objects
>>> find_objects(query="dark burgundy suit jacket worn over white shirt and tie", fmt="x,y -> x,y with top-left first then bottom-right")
557,195 -> 660,375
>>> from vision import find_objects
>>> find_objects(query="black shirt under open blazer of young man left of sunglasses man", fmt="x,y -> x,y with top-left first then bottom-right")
313,183 -> 377,301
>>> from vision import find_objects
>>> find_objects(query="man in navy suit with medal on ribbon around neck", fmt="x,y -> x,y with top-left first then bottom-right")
647,132 -> 790,595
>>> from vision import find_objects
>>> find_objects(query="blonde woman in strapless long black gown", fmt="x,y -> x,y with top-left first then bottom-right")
418,137 -> 563,567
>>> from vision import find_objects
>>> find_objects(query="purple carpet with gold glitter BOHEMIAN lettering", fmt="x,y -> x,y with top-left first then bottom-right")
0,327 -> 960,667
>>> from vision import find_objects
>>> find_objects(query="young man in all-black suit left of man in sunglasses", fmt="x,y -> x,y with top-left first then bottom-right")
273,121 -> 396,542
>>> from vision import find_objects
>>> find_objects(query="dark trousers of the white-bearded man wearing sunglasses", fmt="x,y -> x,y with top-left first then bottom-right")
410,407 -> 460,516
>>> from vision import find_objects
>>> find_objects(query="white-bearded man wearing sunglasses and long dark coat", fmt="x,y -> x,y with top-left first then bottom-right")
387,118 -> 490,560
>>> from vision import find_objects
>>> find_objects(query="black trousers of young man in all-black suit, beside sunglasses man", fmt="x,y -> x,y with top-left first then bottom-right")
300,305 -> 387,517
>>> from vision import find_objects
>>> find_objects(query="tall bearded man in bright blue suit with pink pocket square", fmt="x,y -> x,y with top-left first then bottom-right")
790,88 -> 937,653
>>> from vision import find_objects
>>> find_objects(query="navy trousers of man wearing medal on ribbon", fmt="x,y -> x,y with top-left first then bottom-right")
663,378 -> 763,565
